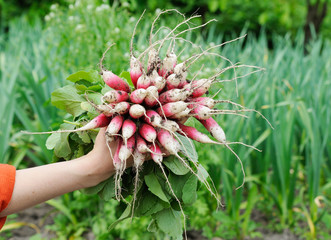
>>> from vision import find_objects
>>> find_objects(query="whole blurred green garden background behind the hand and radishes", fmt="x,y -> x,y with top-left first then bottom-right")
0,0 -> 331,240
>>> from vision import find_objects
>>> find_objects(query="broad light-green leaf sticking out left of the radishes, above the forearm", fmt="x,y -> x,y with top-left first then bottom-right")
51,85 -> 85,117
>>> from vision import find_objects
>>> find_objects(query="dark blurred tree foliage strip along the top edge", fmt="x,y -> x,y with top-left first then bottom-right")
0,0 -> 331,38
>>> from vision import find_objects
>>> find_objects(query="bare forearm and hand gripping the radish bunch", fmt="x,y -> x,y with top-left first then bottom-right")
0,128 -> 124,217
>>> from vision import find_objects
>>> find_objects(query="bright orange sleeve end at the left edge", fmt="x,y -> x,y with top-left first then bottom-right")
0,164 -> 16,229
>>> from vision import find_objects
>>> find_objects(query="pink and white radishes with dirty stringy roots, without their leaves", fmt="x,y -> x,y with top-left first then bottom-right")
26,10 -> 270,238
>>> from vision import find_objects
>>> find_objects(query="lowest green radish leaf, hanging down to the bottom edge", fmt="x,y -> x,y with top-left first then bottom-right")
154,208 -> 183,239
